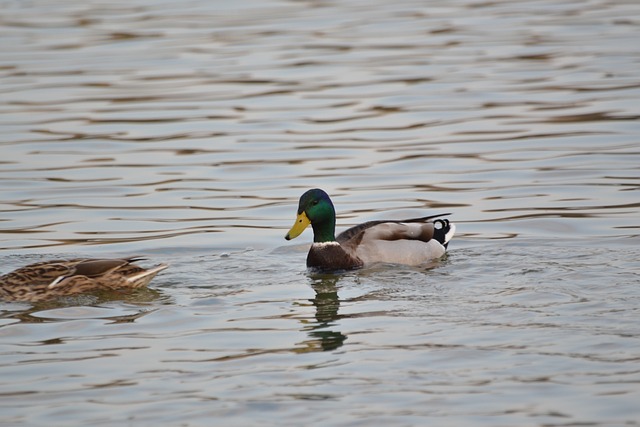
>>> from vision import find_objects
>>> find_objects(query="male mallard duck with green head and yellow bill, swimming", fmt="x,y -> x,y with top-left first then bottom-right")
285,188 -> 456,270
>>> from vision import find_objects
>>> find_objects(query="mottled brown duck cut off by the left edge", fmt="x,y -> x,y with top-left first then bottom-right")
0,257 -> 168,302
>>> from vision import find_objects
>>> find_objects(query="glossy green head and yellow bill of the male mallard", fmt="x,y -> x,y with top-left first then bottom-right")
284,188 -> 336,242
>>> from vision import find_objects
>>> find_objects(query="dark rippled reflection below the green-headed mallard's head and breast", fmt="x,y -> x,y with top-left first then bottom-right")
304,274 -> 347,351
